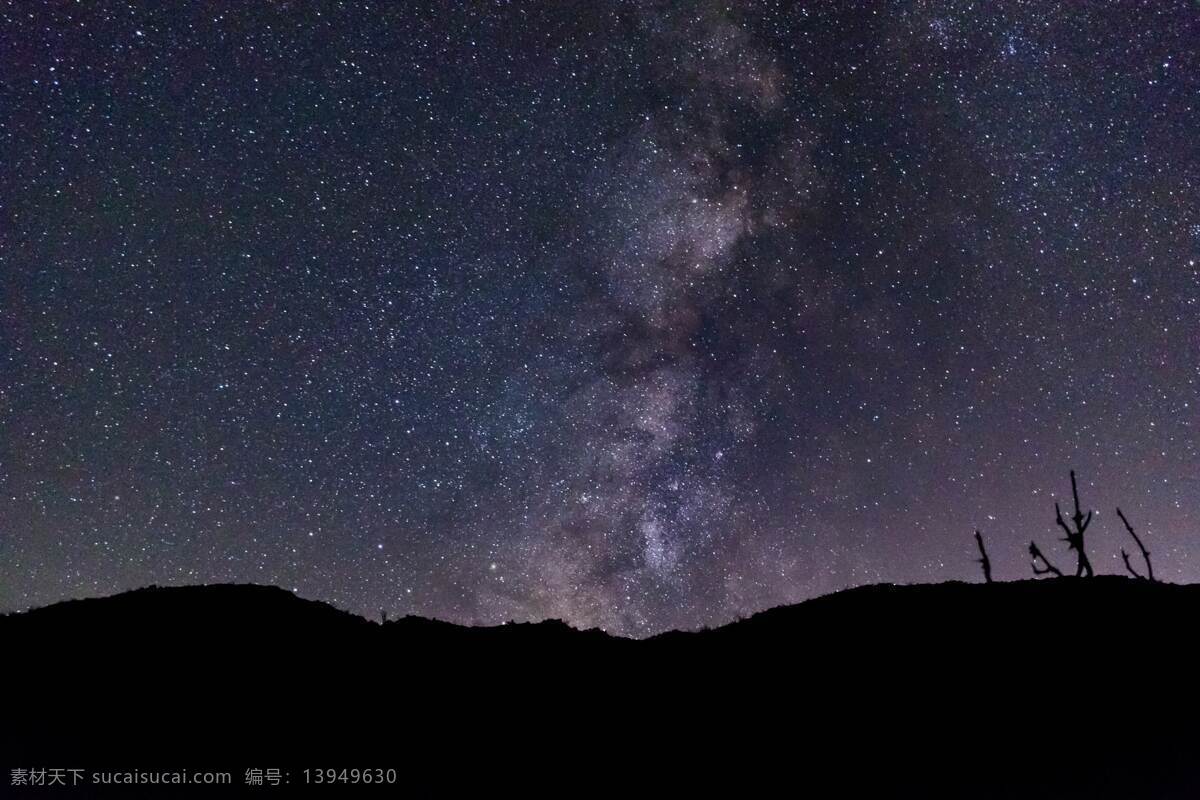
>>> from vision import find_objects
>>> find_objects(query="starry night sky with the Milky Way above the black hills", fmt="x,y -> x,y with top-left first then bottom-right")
0,0 -> 1200,636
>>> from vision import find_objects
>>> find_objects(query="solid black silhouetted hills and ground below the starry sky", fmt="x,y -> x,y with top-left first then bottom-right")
0,577 -> 1200,799
